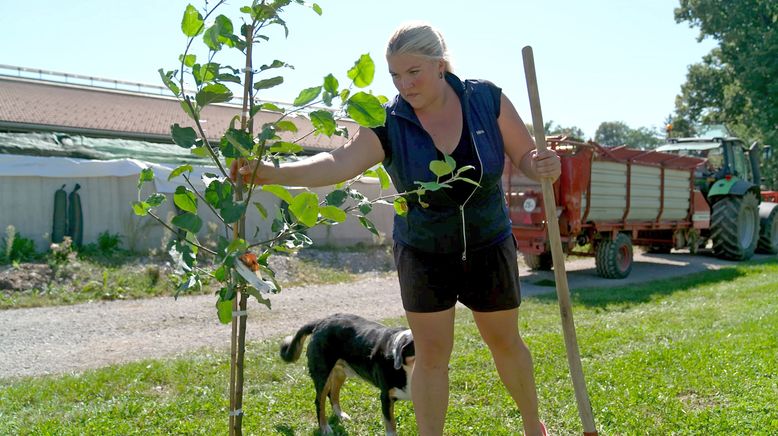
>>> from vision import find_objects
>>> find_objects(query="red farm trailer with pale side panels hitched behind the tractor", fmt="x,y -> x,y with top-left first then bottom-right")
503,137 -> 710,278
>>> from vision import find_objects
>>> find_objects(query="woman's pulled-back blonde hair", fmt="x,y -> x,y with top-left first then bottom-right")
386,22 -> 453,73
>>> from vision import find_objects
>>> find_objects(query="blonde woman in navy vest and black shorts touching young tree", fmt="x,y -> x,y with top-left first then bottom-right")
233,24 -> 560,435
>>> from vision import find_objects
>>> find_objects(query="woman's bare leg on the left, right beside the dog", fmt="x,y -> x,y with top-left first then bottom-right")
405,308 -> 454,436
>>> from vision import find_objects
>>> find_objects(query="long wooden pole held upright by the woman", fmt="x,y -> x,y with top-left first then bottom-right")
521,46 -> 597,436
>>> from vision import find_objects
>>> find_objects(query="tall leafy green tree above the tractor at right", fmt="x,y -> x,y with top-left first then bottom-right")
672,0 -> 778,187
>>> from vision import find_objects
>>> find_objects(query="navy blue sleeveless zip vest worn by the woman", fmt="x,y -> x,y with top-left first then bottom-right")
383,73 -> 511,259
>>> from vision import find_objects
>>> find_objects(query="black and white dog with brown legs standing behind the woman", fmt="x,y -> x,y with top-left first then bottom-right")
281,314 -> 415,435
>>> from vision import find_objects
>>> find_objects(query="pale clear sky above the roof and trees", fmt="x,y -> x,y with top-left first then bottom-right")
0,0 -> 715,138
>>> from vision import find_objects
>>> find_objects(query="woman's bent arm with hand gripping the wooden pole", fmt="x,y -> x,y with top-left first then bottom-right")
497,94 -> 562,180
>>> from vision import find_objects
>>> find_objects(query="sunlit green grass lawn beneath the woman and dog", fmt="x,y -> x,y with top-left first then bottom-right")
0,260 -> 778,435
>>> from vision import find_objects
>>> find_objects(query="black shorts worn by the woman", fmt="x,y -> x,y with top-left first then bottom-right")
394,235 -> 521,312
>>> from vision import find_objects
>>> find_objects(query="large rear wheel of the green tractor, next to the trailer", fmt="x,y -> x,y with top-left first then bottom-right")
711,192 -> 759,260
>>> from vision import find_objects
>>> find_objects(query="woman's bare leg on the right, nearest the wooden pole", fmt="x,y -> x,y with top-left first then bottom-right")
473,308 -> 543,436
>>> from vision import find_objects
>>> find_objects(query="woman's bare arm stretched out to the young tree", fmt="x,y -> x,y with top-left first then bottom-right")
238,127 -> 384,188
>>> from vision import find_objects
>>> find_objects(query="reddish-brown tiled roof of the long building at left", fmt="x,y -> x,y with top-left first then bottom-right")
0,68 -> 357,161
